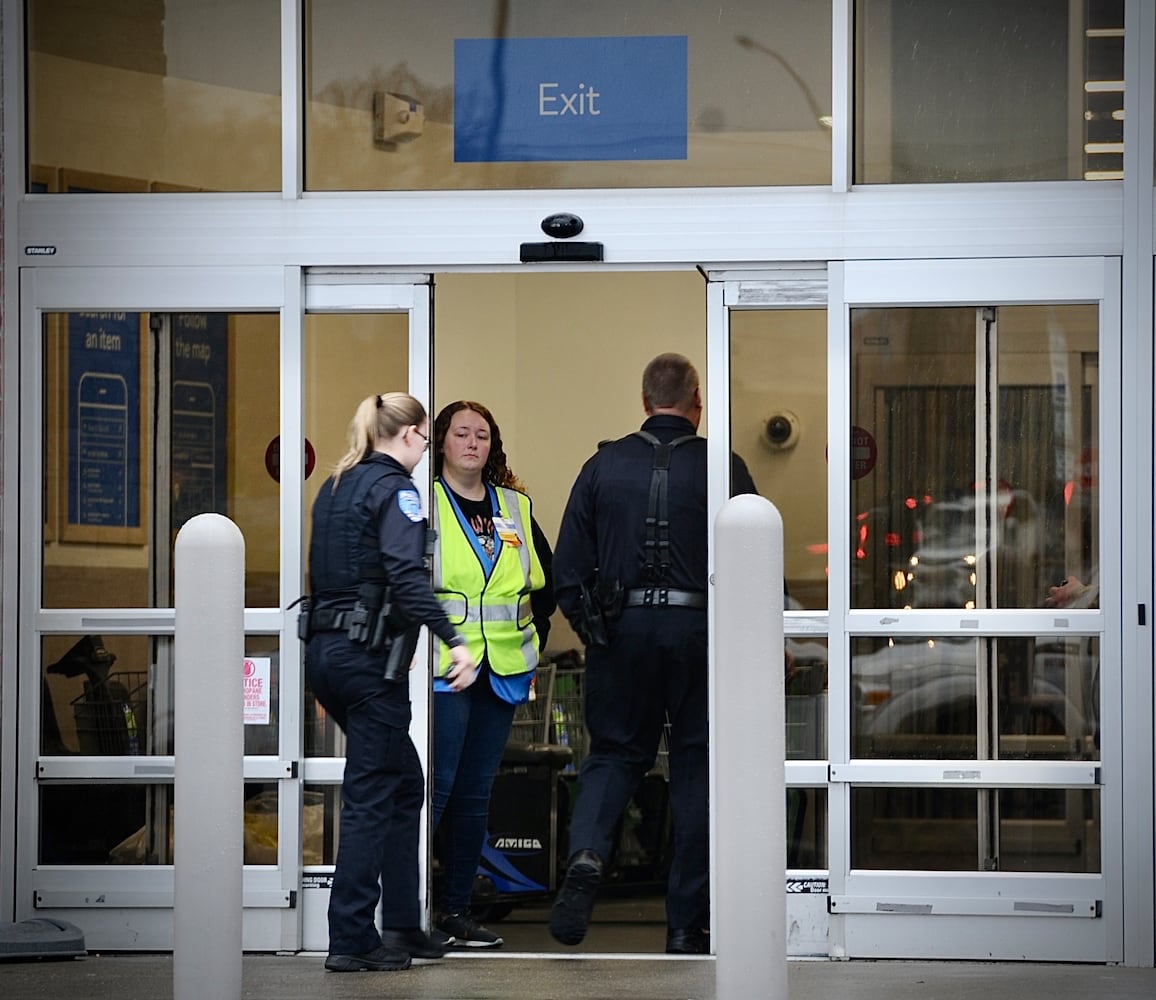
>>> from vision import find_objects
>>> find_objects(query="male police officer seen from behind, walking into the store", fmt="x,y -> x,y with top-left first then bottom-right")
550,354 -> 756,954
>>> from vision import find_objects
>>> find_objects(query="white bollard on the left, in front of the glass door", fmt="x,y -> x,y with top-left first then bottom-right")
172,513 -> 245,1000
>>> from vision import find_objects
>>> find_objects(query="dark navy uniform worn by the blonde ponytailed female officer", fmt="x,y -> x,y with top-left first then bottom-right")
305,452 -> 462,956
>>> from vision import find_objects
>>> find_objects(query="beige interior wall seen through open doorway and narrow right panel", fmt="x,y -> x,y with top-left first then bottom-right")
435,272 -> 827,651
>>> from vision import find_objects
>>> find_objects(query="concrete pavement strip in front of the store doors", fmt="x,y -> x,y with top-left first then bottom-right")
0,953 -> 1156,1000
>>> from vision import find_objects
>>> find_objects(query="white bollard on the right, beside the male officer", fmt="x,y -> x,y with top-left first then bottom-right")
711,495 -> 787,1000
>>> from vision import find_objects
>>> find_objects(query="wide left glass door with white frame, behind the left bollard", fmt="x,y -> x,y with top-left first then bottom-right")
17,268 -> 297,949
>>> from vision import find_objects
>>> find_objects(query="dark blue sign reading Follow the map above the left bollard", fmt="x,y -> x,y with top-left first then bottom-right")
171,313 -> 229,532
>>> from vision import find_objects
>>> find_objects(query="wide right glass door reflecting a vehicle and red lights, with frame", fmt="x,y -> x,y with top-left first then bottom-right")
831,261 -> 1119,961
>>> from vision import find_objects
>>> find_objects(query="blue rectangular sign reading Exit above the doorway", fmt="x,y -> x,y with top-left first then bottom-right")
453,35 -> 687,163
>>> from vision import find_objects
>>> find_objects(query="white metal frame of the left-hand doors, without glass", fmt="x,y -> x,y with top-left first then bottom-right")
12,267 -> 431,950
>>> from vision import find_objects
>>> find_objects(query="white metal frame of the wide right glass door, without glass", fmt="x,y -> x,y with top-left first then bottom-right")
829,258 -> 1135,962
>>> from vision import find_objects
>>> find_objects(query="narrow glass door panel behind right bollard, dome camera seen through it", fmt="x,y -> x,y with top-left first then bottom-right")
707,277 -> 829,955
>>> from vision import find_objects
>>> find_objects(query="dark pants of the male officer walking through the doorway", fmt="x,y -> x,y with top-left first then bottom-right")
570,608 -> 710,929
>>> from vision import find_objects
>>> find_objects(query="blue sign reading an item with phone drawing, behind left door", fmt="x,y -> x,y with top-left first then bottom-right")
68,312 -> 141,528
